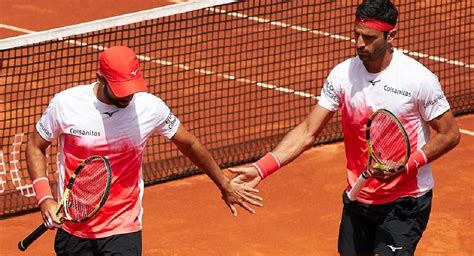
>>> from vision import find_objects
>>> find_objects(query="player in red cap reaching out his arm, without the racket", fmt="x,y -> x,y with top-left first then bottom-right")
26,46 -> 261,256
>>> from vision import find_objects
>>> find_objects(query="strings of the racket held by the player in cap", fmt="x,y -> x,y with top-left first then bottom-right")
66,159 -> 107,220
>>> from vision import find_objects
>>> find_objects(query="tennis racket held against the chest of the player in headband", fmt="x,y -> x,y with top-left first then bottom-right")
348,109 -> 410,201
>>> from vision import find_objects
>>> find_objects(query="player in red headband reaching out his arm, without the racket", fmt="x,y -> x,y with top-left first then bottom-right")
232,0 -> 460,255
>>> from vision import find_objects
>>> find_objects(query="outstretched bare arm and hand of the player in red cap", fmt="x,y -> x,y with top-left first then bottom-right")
171,125 -> 262,216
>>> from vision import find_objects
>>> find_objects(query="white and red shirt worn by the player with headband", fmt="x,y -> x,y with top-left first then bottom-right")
318,50 -> 450,204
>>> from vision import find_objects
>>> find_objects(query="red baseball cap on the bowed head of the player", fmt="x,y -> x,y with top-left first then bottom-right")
99,46 -> 147,98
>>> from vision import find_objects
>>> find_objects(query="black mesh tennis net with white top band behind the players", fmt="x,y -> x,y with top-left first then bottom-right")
0,0 -> 474,216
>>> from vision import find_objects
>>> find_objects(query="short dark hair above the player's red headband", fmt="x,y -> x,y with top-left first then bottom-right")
356,0 -> 398,26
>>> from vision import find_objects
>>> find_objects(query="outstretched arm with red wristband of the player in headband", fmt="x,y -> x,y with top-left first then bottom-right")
229,105 -> 335,188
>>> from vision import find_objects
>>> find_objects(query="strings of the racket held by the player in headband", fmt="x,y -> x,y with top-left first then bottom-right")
370,114 -> 407,169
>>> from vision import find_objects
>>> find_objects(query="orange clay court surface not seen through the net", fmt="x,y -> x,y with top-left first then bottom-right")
0,0 -> 474,256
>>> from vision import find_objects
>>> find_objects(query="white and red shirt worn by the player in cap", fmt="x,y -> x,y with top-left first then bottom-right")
36,83 -> 180,238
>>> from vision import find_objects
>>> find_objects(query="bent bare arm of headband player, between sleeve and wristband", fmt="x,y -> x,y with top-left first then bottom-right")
422,110 -> 461,162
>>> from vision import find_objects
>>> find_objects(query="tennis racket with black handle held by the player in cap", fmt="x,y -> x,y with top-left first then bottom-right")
18,156 -> 112,251
